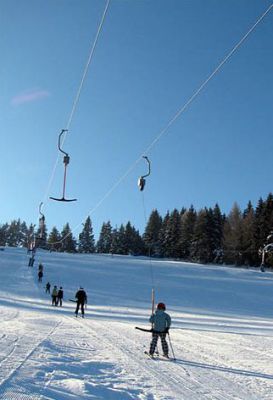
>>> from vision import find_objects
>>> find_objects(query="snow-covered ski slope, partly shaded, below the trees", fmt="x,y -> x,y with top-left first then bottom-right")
0,248 -> 273,400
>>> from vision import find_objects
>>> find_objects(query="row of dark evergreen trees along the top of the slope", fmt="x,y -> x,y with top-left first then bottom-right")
0,193 -> 273,266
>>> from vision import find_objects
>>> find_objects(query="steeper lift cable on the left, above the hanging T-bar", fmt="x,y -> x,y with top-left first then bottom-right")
39,0 -> 111,211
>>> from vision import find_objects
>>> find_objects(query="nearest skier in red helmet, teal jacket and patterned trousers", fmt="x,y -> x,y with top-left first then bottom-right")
149,303 -> 171,357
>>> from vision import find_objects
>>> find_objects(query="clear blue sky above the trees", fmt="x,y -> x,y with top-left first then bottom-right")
0,0 -> 273,236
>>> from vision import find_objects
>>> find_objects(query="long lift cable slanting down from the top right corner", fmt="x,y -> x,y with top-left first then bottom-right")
50,3 -> 273,245
